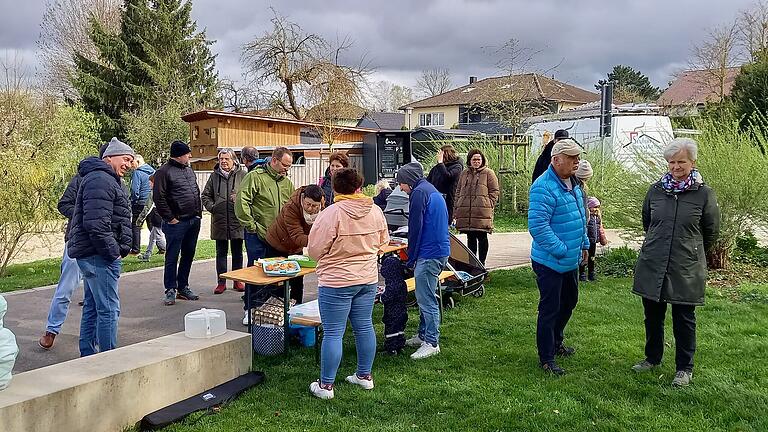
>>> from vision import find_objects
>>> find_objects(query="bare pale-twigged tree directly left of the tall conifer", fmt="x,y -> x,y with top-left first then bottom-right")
37,0 -> 122,99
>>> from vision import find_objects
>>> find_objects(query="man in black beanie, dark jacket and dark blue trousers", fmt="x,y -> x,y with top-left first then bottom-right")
152,141 -> 203,306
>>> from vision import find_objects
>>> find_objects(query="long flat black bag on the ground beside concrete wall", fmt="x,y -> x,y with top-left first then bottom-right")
140,371 -> 265,431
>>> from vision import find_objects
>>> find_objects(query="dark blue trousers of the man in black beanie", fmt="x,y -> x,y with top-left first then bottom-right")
163,217 -> 200,292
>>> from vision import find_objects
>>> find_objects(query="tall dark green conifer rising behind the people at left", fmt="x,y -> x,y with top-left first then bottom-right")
72,0 -> 217,138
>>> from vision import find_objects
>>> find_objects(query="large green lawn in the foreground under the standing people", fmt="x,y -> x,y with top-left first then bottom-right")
158,269 -> 768,432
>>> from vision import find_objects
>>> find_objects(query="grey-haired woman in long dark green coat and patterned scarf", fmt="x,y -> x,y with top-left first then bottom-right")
632,138 -> 720,387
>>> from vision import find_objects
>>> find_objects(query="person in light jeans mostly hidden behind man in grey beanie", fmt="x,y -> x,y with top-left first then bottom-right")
37,144 -> 107,349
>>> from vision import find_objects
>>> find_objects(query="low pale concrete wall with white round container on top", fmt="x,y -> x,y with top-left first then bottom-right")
0,330 -> 251,432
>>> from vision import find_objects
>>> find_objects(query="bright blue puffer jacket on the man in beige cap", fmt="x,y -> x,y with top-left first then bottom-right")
528,166 -> 589,273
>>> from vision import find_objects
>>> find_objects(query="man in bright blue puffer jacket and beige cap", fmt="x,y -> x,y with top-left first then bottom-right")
528,139 -> 589,375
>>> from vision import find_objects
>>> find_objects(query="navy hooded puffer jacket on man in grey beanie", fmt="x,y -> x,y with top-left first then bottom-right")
67,157 -> 132,262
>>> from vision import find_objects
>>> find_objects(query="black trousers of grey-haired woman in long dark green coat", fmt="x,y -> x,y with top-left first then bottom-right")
643,298 -> 696,372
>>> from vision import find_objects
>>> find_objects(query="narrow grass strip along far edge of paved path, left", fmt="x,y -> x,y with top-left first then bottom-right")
0,240 -> 216,293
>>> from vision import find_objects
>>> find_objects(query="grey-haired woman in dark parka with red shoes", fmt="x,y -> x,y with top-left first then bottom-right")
201,148 -> 246,294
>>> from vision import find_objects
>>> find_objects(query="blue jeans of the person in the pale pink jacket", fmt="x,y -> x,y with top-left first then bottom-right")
317,284 -> 376,384
